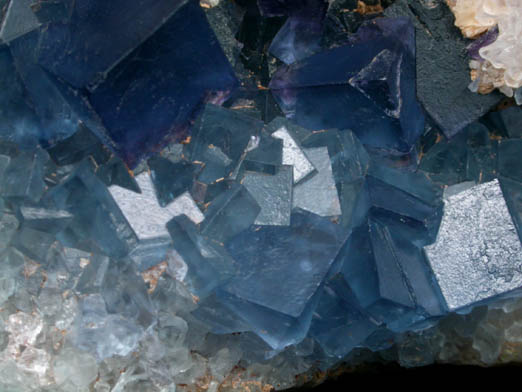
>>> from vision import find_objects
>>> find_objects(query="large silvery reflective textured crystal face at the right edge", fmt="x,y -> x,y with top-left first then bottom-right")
425,180 -> 522,310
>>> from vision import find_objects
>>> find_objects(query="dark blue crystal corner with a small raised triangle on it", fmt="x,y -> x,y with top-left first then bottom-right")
270,18 -> 424,154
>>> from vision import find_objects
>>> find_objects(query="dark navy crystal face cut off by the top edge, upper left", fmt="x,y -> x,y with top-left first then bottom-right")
36,0 -> 185,88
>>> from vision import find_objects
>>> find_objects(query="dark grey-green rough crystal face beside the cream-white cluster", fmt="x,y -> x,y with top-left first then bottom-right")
385,0 -> 500,137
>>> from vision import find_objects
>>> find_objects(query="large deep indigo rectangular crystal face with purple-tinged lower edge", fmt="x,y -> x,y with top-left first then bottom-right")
89,1 -> 237,165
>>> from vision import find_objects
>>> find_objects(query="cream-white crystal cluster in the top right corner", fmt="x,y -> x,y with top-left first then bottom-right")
448,0 -> 522,104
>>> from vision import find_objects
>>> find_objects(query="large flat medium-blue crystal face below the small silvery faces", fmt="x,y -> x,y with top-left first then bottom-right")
225,210 -> 346,317
